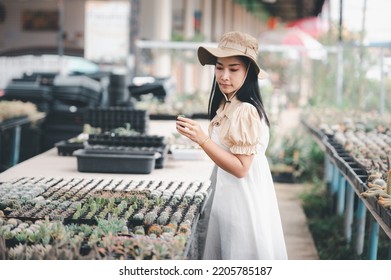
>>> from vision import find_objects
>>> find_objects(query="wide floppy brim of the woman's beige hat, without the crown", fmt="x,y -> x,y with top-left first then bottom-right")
197,47 -> 268,79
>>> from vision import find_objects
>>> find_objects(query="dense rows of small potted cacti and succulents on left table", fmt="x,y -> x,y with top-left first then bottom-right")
0,178 -> 210,259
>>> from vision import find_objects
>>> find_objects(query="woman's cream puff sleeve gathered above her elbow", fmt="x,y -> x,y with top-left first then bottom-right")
228,103 -> 261,155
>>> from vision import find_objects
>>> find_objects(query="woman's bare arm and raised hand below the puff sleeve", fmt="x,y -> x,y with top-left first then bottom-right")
176,117 -> 254,178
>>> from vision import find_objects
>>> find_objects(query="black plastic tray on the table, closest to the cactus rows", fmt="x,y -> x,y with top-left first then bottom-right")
73,150 -> 156,174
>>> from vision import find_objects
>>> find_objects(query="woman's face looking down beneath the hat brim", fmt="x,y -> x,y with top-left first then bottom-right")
215,56 -> 247,97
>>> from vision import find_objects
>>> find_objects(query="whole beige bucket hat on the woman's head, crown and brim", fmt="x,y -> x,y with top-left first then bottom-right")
197,31 -> 268,79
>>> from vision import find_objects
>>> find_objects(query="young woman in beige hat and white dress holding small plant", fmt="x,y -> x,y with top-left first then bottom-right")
176,31 -> 287,260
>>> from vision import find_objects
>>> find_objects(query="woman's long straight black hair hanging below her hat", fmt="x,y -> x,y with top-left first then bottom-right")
208,56 -> 270,126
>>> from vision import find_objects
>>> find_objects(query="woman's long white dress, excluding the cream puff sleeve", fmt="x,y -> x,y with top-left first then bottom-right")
203,116 -> 287,260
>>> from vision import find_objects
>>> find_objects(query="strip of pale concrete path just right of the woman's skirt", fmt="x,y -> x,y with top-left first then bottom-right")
275,183 -> 319,260
